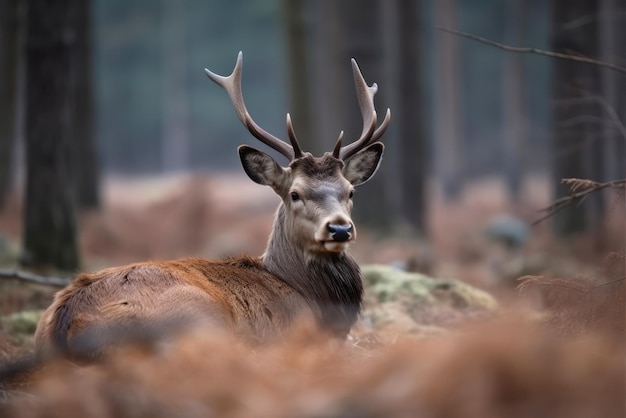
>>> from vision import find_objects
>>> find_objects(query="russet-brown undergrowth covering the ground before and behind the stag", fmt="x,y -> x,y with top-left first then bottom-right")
0,172 -> 626,418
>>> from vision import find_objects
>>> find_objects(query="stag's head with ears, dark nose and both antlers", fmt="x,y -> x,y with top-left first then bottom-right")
205,52 -> 391,254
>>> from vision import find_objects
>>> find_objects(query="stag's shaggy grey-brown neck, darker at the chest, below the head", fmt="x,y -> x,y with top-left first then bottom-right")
263,204 -> 363,337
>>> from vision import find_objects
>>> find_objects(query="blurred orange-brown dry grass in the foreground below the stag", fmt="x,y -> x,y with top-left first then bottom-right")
0,320 -> 626,418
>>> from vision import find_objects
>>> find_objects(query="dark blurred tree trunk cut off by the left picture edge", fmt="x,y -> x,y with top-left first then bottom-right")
0,0 -> 20,210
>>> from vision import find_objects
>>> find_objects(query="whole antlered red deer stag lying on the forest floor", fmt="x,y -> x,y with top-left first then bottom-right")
35,52 -> 391,356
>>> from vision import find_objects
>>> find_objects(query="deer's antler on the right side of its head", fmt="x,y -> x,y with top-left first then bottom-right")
333,58 -> 391,160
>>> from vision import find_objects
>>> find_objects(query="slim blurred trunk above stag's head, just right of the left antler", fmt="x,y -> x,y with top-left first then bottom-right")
283,0 -> 314,155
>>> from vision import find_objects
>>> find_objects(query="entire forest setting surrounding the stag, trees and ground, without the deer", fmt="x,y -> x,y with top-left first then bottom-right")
0,0 -> 626,418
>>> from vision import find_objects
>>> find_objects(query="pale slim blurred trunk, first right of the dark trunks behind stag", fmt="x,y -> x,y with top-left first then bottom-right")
435,0 -> 463,199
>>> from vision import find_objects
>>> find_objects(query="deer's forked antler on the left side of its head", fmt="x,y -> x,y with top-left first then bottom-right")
204,51 -> 292,161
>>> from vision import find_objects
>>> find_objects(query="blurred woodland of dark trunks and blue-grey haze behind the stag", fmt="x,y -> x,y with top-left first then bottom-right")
0,0 -> 626,280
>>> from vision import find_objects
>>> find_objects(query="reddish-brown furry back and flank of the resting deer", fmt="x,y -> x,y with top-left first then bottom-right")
35,257 -> 310,352
